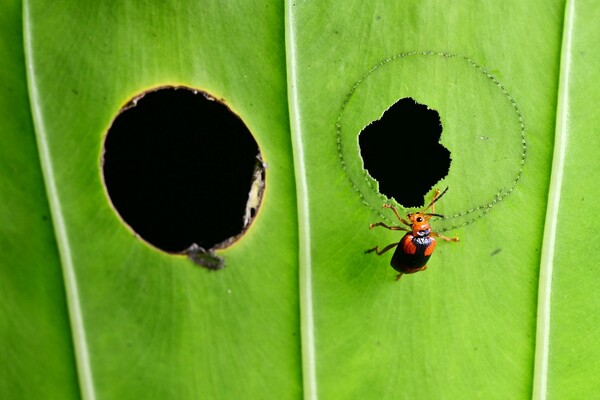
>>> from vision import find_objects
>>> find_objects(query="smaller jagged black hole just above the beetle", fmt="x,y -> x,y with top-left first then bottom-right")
359,98 -> 450,207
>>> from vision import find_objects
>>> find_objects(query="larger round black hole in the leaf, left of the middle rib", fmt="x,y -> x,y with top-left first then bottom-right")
103,88 -> 259,252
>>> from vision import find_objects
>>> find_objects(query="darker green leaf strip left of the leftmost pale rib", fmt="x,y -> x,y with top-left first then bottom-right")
0,1 -> 78,399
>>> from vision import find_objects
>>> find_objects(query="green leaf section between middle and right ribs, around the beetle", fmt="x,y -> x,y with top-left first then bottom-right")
288,1 -> 561,398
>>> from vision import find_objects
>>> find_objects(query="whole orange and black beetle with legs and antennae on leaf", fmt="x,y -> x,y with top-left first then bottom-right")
365,188 -> 459,280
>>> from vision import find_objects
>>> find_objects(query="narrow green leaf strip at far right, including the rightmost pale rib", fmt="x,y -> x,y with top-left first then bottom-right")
534,1 -> 600,399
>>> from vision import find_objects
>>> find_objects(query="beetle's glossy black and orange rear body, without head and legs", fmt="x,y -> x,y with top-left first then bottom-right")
390,233 -> 437,274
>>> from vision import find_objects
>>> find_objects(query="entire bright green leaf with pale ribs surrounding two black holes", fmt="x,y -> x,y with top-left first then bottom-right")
0,0 -> 600,399
